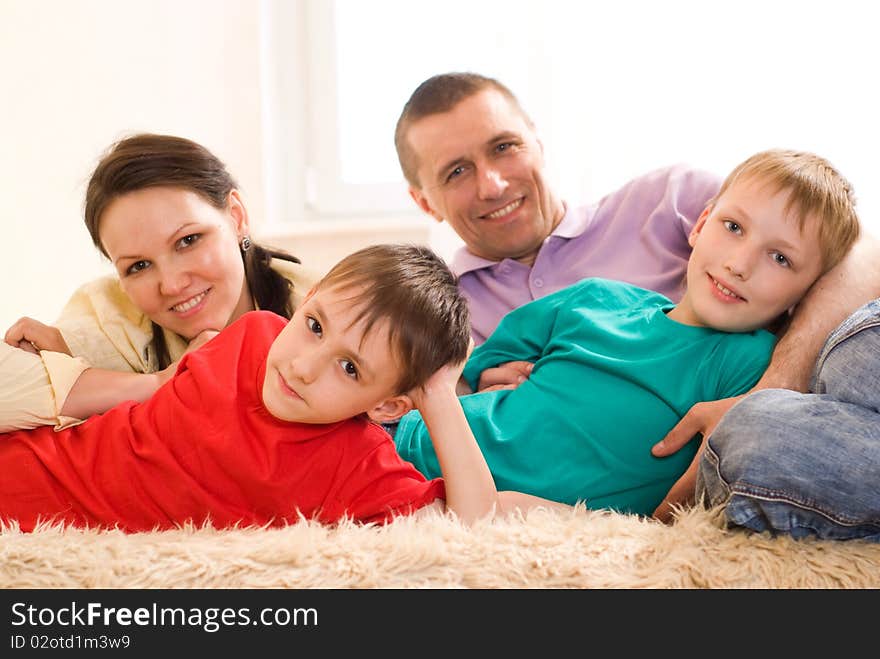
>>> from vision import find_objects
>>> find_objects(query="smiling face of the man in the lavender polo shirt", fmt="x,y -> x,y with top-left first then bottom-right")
406,89 -> 565,264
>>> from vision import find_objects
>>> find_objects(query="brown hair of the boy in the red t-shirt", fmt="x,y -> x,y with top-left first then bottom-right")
315,244 -> 471,393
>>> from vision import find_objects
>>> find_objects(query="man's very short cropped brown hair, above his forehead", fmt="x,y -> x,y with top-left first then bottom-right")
394,73 -> 533,187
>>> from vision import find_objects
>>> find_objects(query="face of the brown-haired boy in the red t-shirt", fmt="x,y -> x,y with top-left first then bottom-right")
263,289 -> 409,424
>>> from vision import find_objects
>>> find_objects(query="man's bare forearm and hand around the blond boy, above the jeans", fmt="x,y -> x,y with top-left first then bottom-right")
651,233 -> 880,521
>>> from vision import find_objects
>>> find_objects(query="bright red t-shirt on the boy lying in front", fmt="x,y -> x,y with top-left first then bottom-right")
0,311 -> 445,531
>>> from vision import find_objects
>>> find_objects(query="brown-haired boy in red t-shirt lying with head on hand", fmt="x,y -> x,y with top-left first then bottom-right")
0,245 -> 552,531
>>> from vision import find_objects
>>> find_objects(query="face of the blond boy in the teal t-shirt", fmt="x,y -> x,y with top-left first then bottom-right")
669,179 -> 822,332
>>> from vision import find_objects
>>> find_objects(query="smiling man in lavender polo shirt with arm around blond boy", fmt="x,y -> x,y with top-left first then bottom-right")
395,73 -> 880,519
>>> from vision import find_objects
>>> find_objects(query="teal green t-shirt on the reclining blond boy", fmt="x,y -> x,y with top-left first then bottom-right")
394,278 -> 776,515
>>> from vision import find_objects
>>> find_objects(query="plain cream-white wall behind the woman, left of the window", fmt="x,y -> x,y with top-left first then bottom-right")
0,0 -> 264,331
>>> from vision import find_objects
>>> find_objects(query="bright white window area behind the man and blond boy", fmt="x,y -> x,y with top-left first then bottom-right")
288,0 -> 880,233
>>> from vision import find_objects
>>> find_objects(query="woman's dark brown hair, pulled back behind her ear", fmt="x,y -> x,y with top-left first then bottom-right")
84,133 -> 300,369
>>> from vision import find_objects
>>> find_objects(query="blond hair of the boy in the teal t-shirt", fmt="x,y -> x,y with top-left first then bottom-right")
710,149 -> 860,273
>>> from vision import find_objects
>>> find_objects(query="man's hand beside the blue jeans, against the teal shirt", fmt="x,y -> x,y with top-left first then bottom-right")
651,394 -> 745,522
